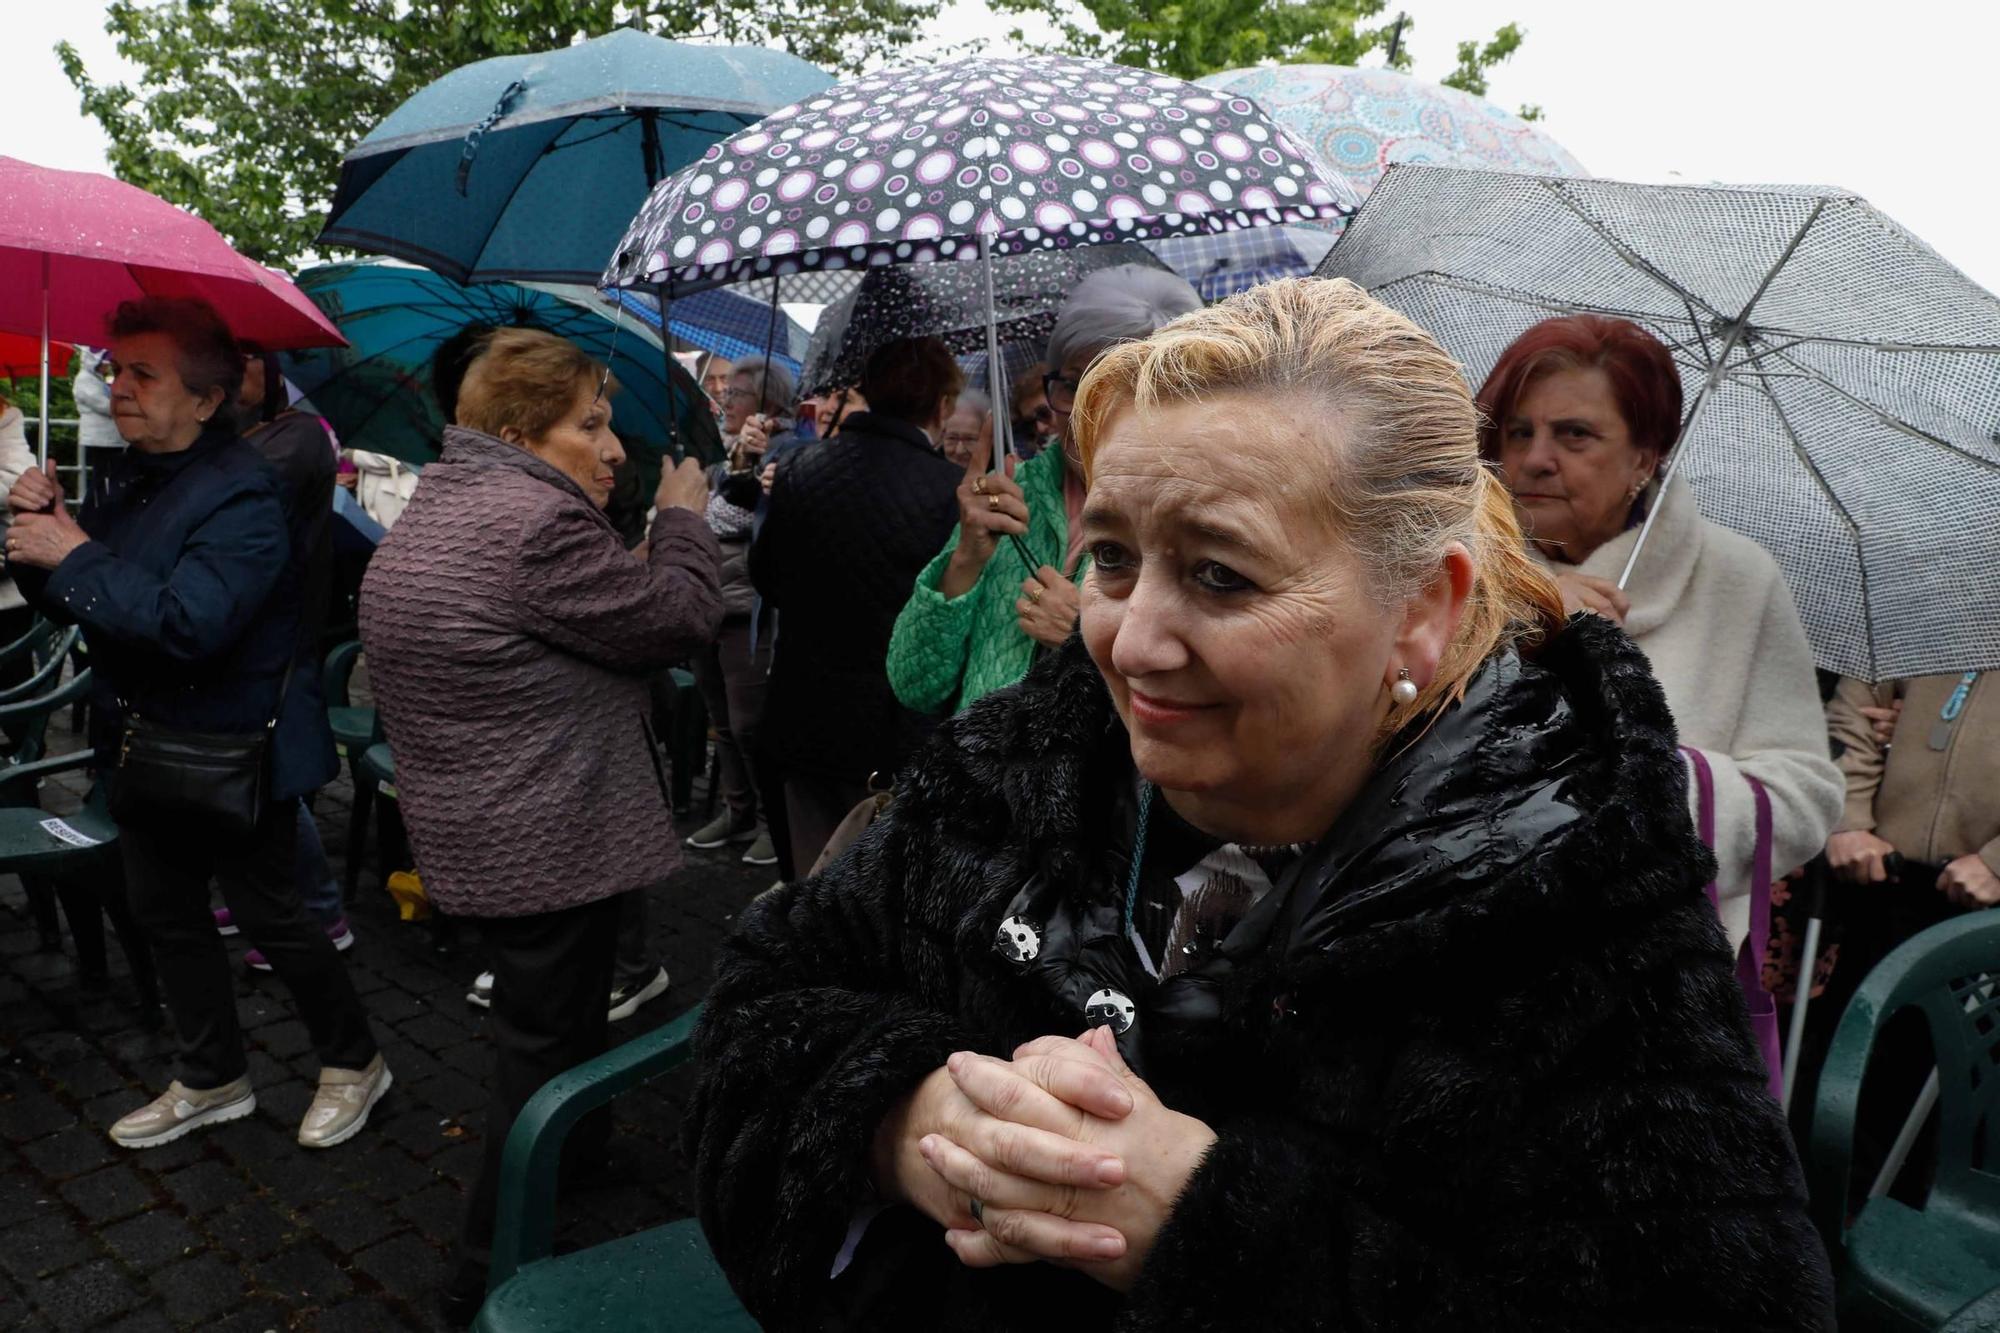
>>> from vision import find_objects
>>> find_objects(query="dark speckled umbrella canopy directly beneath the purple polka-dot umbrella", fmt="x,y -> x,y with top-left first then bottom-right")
800,244 -> 1166,394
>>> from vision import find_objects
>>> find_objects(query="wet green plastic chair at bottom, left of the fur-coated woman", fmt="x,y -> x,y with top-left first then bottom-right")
472,1007 -> 758,1333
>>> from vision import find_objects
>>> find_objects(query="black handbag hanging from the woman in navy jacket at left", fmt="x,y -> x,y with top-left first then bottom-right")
108,662 -> 298,837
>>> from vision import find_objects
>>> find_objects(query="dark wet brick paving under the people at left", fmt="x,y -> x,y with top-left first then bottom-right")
0,725 -> 770,1333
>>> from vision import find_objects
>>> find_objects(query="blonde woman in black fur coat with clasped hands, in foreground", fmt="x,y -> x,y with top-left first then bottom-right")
688,280 -> 1832,1333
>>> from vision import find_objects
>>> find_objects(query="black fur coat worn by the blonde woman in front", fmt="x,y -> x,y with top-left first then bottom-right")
688,616 -> 1832,1333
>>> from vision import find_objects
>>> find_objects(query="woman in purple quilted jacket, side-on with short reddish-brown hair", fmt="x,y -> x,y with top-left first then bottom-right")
360,328 -> 722,1315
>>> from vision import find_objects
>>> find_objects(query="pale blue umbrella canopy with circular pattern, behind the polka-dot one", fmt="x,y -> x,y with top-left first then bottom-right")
1200,64 -> 1590,194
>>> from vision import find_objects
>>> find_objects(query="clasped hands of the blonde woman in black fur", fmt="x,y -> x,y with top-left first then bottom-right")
876,1027 -> 1216,1291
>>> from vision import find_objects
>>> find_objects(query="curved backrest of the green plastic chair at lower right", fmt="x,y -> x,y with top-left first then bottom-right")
1808,911 -> 2000,1247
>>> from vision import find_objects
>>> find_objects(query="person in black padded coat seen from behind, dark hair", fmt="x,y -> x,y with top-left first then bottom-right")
750,338 -> 964,875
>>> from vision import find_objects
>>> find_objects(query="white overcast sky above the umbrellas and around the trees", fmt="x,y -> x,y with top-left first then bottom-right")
15,0 -> 2000,290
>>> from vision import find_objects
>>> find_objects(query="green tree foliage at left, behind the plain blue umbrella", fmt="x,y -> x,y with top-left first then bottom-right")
56,0 -> 942,264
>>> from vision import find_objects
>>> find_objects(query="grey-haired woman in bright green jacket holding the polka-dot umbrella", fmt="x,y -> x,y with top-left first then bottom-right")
888,264 -> 1202,713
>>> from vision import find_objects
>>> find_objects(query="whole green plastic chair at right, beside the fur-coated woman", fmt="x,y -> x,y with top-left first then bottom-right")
1808,911 -> 2000,1333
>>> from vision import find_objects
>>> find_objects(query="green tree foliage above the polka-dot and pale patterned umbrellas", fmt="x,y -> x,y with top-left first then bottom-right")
992,0 -> 1540,114
